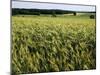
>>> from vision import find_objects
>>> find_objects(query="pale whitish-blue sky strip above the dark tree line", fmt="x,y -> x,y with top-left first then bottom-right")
12,1 -> 95,11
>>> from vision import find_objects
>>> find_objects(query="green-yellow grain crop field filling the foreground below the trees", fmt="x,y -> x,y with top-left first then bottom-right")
11,15 -> 96,74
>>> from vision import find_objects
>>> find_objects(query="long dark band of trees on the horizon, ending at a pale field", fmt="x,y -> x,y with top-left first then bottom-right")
12,8 -> 76,17
